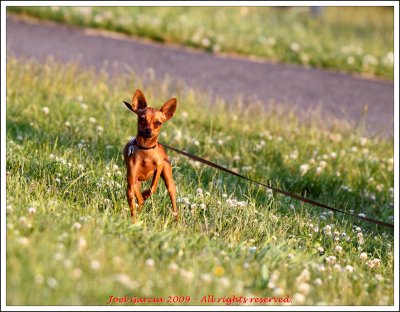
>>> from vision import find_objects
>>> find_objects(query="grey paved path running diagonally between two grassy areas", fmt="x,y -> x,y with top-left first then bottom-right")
7,16 -> 394,136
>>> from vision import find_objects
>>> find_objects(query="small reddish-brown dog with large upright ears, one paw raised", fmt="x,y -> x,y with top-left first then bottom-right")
124,90 -> 178,222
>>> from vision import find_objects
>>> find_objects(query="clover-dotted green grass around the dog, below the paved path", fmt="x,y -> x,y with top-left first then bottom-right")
6,58 -> 394,305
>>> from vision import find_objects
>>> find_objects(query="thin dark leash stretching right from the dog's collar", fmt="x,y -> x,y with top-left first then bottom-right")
159,142 -> 394,229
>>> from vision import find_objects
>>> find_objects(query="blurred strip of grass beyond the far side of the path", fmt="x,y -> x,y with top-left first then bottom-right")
8,7 -> 394,79
